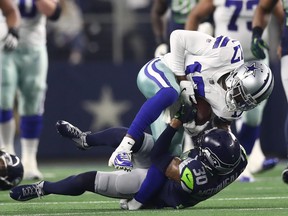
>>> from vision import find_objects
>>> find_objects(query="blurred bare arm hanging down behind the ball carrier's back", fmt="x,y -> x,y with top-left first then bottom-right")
150,0 -> 168,45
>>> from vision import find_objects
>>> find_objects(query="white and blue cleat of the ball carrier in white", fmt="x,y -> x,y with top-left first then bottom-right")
108,151 -> 133,171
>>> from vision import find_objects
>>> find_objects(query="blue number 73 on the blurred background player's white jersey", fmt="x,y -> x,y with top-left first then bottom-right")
225,0 -> 258,31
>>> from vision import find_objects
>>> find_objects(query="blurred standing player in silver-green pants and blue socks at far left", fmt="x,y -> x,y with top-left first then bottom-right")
0,0 -> 61,179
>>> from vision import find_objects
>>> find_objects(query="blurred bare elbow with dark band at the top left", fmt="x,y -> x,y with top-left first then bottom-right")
36,0 -> 61,21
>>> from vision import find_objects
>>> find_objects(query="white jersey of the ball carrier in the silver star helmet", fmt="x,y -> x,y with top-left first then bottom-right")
163,30 -> 244,120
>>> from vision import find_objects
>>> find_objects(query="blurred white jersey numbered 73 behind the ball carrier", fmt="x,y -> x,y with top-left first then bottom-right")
213,0 -> 268,61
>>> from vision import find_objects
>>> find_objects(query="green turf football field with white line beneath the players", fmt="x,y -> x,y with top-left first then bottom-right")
0,160 -> 288,216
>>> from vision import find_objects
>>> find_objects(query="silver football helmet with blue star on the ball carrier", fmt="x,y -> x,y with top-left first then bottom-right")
225,61 -> 274,111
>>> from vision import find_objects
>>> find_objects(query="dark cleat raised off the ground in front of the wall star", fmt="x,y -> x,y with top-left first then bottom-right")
56,120 -> 91,150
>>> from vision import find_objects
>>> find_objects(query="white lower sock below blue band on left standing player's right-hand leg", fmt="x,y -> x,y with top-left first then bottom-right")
21,138 -> 39,172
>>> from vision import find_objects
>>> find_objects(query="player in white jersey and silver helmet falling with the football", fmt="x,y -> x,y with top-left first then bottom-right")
109,30 -> 274,173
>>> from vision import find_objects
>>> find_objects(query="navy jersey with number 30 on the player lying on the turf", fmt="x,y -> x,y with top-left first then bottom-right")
151,149 -> 247,209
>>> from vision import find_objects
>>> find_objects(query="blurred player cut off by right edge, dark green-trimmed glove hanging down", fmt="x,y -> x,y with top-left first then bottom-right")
251,0 -> 288,183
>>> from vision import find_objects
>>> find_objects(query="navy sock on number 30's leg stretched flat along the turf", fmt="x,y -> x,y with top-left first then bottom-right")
43,171 -> 97,196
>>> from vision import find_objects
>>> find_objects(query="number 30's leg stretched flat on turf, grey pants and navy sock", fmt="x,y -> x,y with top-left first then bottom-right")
10,169 -> 147,201
